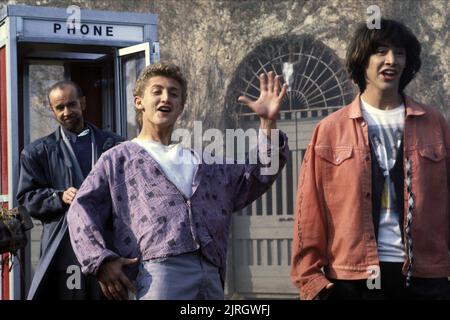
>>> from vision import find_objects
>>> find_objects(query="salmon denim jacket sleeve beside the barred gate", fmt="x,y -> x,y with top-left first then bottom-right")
291,128 -> 330,300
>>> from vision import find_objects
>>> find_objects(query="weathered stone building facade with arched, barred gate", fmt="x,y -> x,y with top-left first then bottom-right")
0,0 -> 450,298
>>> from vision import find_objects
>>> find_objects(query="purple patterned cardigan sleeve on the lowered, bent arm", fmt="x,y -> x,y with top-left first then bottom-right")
67,156 -> 119,275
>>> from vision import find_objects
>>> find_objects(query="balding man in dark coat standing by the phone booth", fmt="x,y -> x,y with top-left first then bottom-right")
17,81 -> 123,300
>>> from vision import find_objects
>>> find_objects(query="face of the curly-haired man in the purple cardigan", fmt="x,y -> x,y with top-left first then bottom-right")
134,76 -> 183,129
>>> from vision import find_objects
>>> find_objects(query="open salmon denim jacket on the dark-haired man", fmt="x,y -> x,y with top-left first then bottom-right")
291,95 -> 450,299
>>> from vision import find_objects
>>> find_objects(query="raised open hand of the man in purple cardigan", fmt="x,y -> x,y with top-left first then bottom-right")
238,71 -> 288,129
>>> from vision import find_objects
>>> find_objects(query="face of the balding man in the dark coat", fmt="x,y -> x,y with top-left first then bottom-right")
49,85 -> 86,133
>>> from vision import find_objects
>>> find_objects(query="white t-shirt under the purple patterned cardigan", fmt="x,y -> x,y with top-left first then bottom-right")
132,138 -> 199,198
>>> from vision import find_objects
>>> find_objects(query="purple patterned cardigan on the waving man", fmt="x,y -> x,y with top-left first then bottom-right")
67,131 -> 288,281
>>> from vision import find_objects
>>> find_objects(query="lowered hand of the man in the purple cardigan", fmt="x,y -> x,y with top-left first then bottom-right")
97,258 -> 138,300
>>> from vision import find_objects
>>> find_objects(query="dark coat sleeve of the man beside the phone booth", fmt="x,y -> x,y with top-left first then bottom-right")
17,148 -> 67,220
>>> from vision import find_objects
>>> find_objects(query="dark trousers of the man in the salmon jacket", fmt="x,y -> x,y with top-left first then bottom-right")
328,262 -> 450,300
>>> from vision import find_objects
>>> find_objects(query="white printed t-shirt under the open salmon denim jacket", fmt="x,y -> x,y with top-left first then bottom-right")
361,98 -> 405,262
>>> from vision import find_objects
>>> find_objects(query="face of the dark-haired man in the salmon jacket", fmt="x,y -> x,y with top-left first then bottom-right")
365,45 -> 406,94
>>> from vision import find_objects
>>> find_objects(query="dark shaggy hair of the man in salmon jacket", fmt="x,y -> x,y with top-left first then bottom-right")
346,19 -> 421,92
